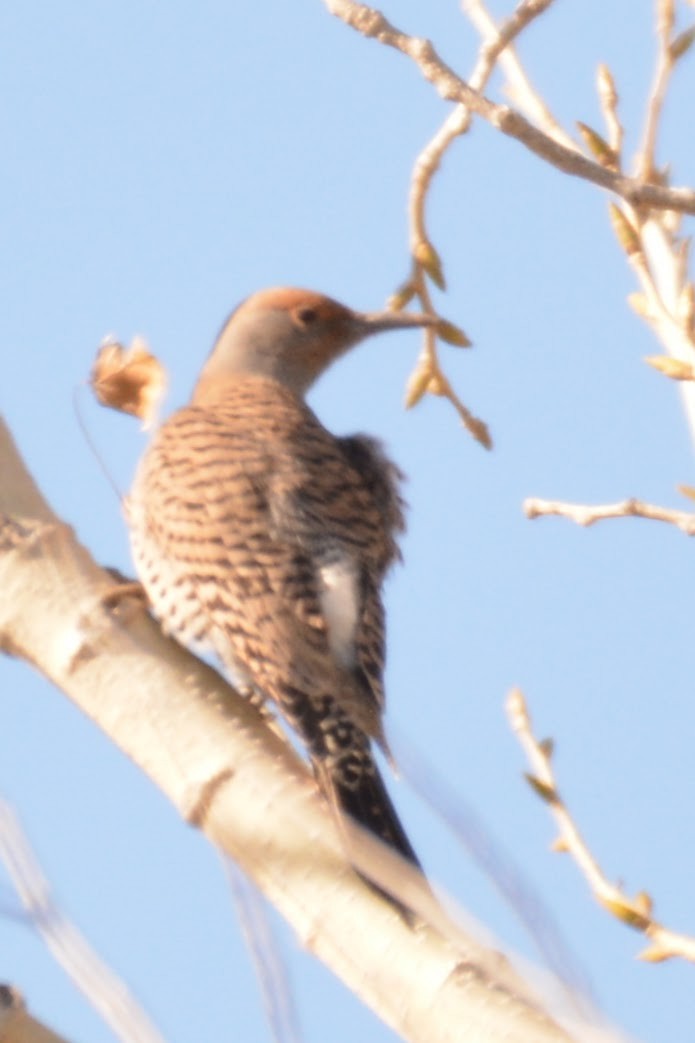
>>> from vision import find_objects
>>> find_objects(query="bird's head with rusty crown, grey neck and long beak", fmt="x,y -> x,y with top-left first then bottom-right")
194,289 -> 434,401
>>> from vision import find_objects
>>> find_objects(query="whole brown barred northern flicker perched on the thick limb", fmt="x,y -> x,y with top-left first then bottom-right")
127,289 -> 431,884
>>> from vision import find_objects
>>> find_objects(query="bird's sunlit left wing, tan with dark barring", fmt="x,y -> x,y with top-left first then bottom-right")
128,398 -> 328,697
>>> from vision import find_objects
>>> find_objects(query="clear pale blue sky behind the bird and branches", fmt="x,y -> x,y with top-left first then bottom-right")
0,0 -> 695,1043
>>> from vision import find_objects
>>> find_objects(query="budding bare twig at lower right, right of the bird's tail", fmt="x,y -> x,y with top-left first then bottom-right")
507,688 -> 695,963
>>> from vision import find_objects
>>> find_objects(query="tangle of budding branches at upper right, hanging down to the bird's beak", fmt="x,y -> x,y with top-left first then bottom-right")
323,0 -> 695,447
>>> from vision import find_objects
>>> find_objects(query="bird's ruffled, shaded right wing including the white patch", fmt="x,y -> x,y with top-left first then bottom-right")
264,423 -> 404,743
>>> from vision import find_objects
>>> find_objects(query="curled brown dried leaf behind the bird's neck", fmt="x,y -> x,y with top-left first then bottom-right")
90,338 -> 167,425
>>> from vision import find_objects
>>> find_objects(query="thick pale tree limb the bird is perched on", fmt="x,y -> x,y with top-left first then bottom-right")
0,415 -> 584,1043
